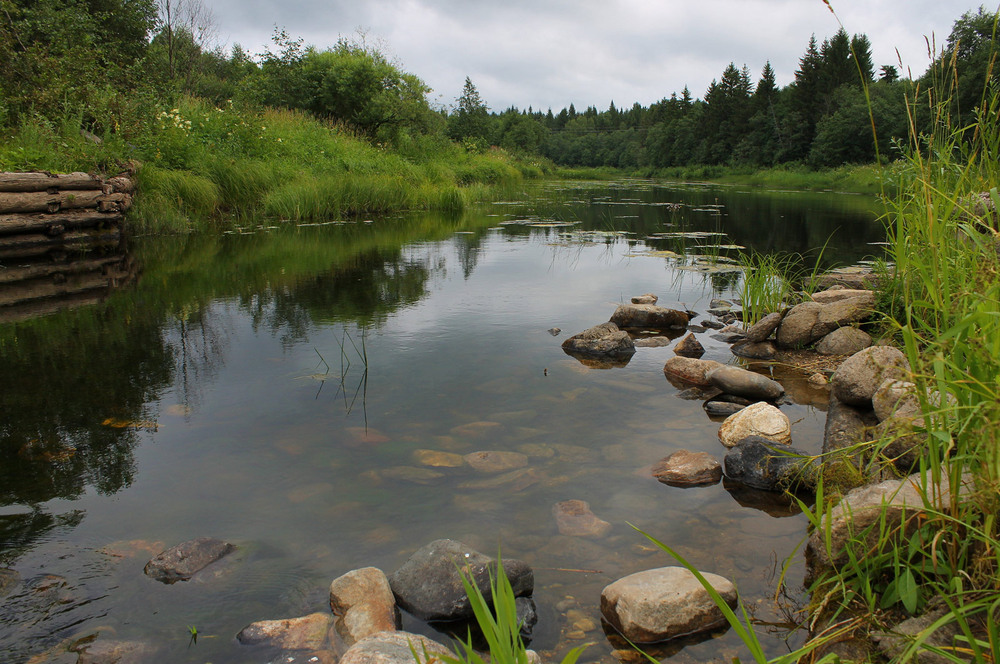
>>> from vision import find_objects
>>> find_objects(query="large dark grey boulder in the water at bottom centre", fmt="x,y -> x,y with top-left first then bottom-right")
389,539 -> 535,621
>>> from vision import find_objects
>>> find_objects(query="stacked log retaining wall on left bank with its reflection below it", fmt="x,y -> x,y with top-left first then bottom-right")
0,172 -> 136,323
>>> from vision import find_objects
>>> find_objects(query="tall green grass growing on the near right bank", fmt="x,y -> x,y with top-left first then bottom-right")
644,13 -> 1000,662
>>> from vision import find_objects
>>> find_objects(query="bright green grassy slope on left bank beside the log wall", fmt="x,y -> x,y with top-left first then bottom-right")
0,98 -> 550,233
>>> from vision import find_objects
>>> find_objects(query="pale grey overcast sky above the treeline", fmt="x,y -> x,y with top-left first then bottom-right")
202,0 -> 980,112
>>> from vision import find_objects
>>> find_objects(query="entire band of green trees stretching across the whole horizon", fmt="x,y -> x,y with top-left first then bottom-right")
0,0 -> 997,173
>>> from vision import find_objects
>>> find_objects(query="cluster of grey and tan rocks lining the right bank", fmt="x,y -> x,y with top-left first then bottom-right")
563,275 -> 971,660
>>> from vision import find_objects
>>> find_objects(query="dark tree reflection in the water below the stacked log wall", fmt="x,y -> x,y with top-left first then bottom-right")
0,314 -> 173,504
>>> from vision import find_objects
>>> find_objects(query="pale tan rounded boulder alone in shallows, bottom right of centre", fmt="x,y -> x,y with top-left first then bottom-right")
601,567 -> 736,643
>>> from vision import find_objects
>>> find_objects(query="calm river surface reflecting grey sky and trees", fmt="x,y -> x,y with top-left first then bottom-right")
0,182 -> 883,664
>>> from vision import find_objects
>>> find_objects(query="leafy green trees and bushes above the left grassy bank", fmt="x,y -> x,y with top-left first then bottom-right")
0,0 -> 445,154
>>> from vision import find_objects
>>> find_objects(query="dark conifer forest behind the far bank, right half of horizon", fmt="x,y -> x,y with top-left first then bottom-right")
449,7 -> 997,170
